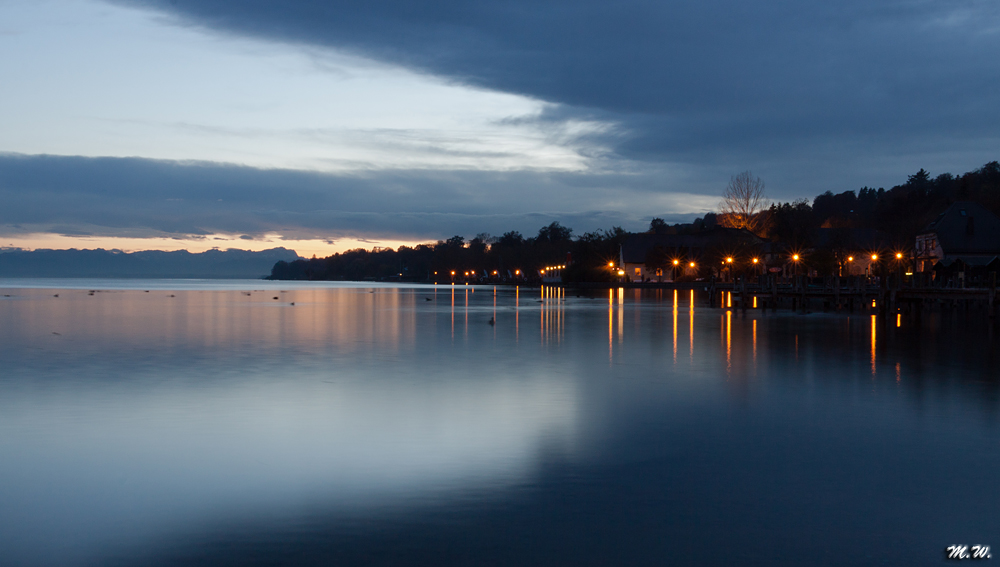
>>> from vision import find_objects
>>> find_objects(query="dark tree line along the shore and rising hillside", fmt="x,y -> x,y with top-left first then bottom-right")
270,161 -> 1000,283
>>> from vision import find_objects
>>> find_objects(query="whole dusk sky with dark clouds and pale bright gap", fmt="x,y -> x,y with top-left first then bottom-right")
0,0 -> 1000,256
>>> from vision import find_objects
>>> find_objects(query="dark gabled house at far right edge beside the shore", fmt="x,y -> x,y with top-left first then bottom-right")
914,201 -> 1000,280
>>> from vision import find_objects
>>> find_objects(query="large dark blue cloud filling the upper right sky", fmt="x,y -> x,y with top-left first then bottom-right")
113,0 -> 1000,177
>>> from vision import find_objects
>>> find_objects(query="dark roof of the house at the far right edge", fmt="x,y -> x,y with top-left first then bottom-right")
921,201 -> 1000,256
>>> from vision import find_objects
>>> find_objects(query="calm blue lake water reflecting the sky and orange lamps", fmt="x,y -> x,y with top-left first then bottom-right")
0,280 -> 1000,566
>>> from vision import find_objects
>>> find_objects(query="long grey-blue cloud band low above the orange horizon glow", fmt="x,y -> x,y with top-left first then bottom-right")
0,154 -> 718,240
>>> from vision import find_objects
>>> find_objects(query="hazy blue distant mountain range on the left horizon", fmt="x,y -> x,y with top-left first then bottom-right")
0,248 -> 300,278
